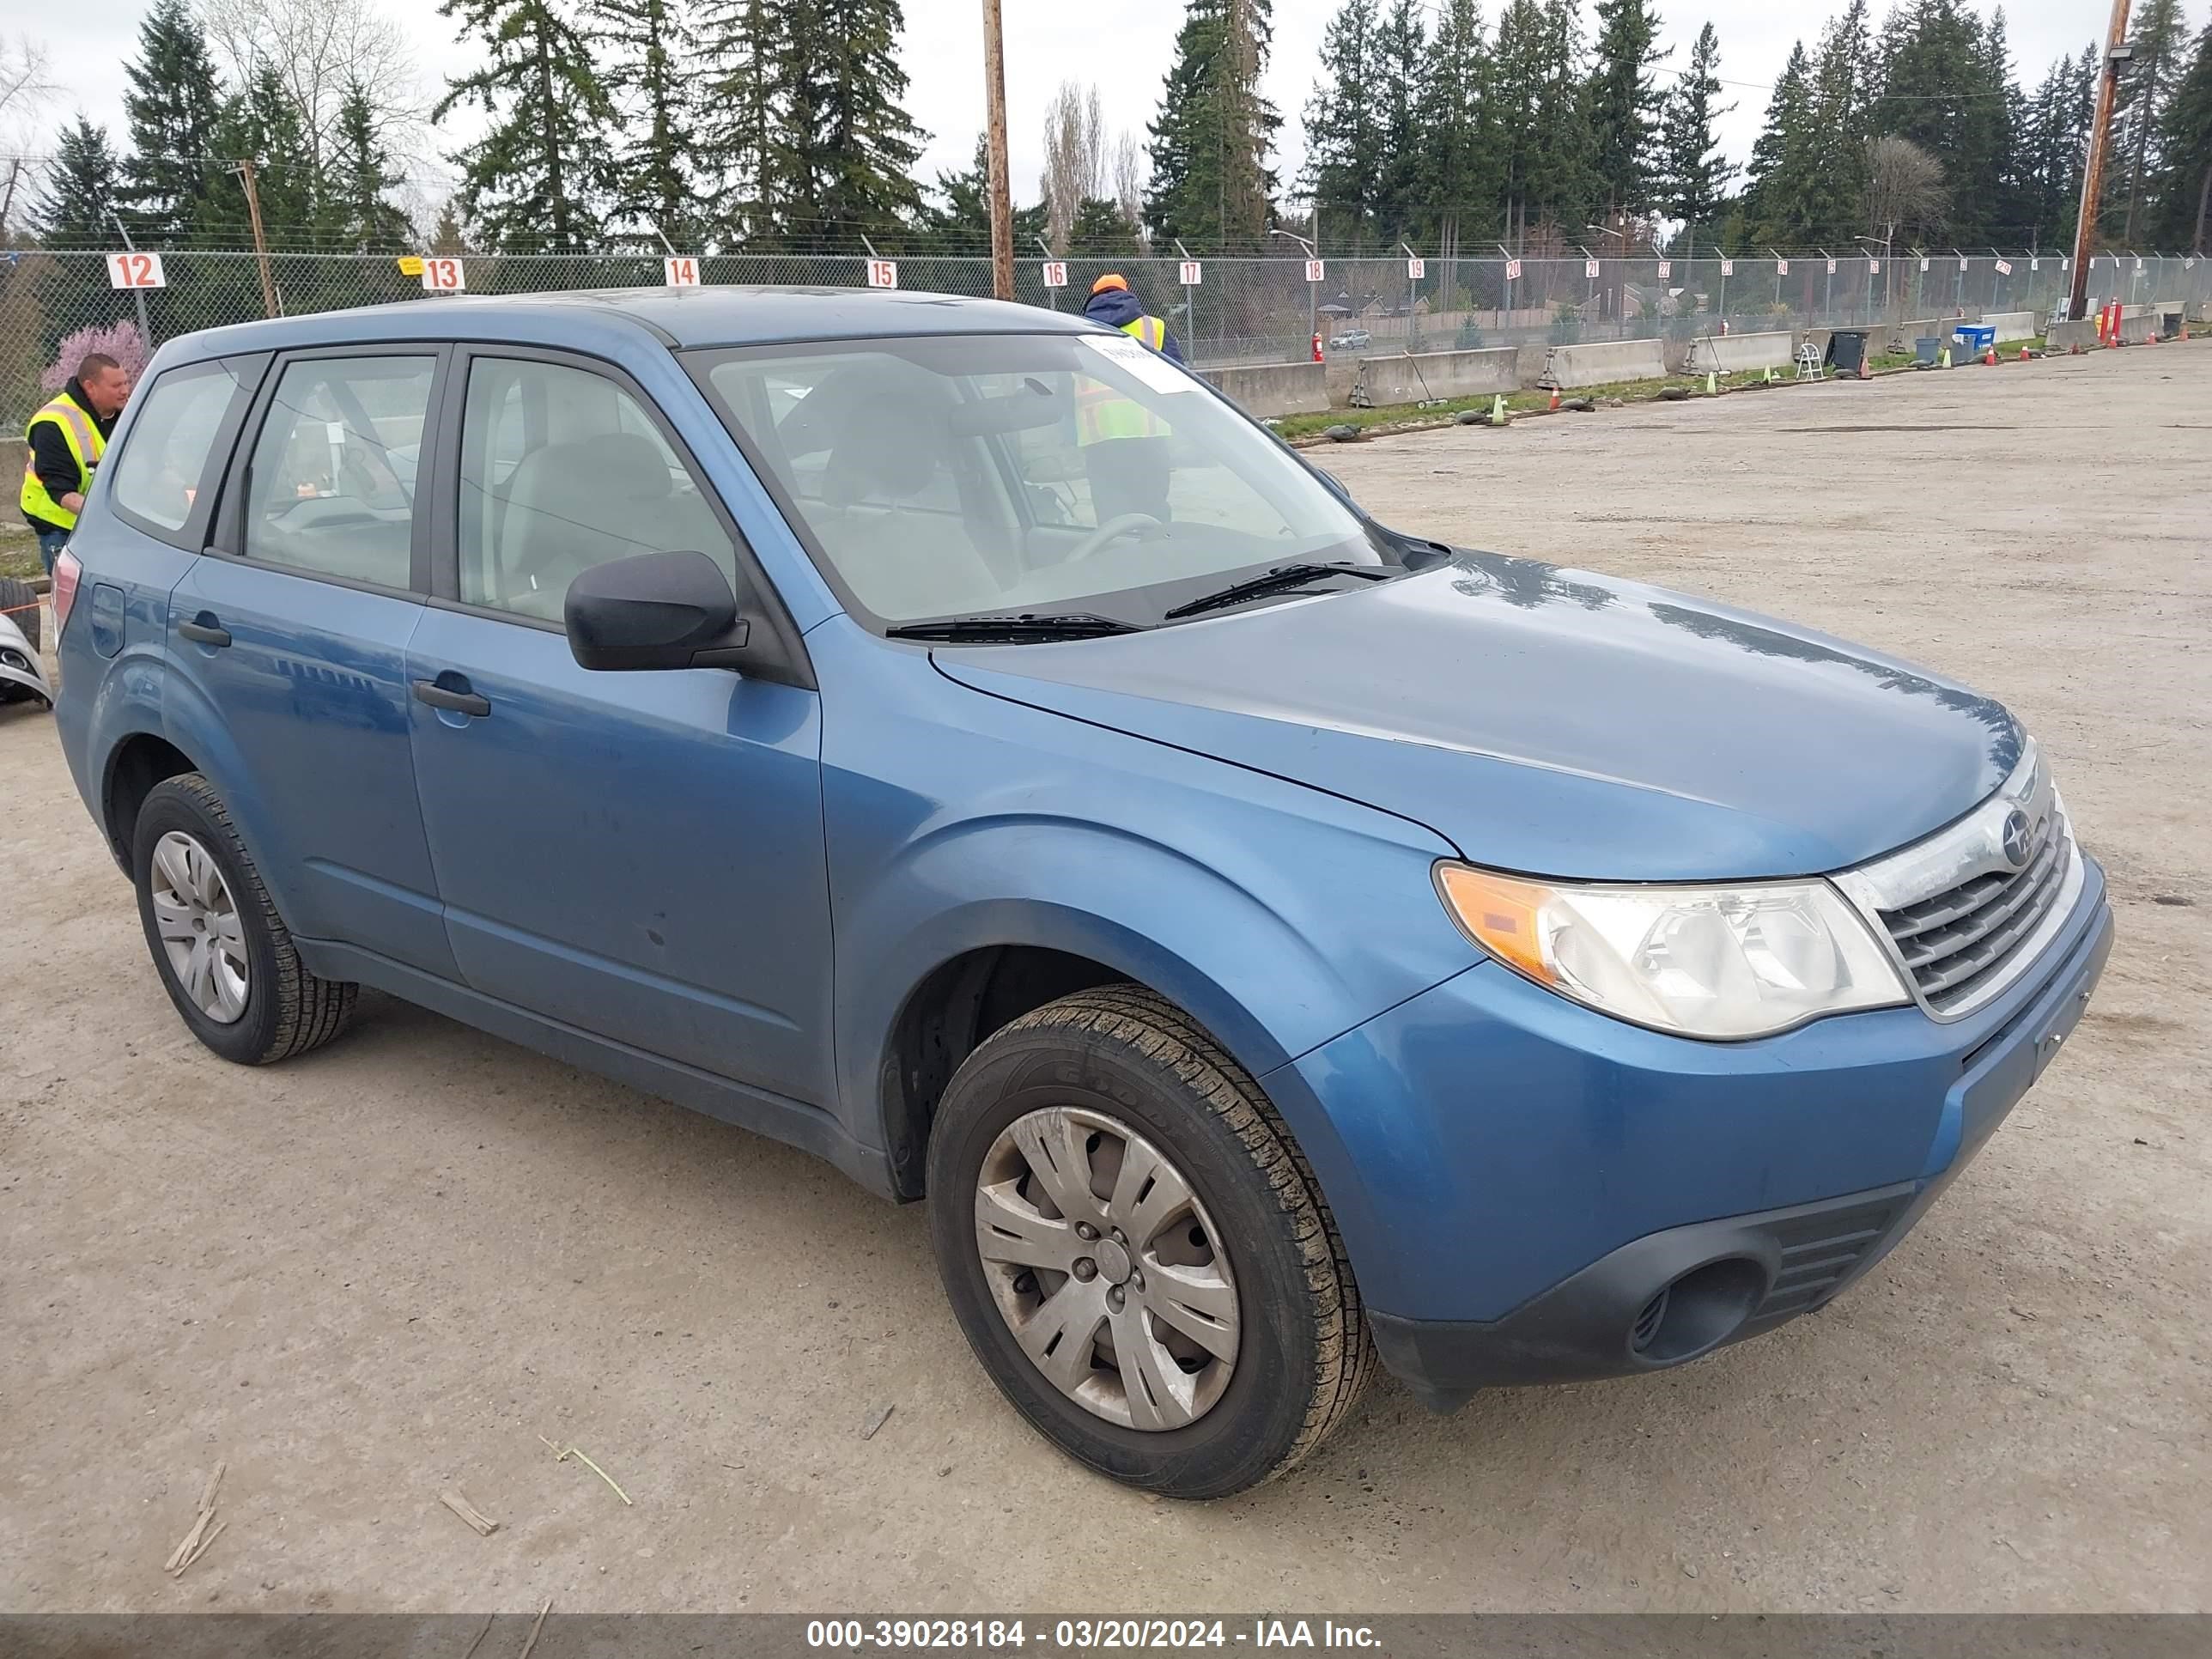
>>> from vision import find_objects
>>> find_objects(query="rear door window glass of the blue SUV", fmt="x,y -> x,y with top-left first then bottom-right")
243,356 -> 438,588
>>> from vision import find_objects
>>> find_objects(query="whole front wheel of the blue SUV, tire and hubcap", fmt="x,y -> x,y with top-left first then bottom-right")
929,987 -> 1374,1498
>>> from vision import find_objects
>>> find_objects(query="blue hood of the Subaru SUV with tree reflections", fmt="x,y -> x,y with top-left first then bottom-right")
936,553 -> 2021,880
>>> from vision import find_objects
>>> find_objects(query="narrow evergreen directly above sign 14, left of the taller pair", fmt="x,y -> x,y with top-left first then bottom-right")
592,0 -> 699,248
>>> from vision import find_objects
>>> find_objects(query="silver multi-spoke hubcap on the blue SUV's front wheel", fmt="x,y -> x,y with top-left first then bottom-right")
975,1106 -> 1239,1431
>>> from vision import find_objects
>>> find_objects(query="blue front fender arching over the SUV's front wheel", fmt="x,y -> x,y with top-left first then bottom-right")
807,623 -> 1475,1273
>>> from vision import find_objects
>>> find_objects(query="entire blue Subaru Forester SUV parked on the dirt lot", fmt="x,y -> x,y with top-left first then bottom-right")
55,288 -> 2112,1498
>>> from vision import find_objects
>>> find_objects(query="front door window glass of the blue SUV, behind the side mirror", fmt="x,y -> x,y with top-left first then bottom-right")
458,356 -> 737,622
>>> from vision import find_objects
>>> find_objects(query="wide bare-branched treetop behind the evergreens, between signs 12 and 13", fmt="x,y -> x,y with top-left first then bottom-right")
199,0 -> 427,170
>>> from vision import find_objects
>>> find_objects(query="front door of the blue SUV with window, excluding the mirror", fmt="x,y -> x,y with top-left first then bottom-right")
407,354 -> 832,1106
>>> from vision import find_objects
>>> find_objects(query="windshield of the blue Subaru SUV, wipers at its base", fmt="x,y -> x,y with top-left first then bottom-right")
695,334 -> 1387,623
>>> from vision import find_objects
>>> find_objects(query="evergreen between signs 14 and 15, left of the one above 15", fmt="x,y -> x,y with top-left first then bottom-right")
696,0 -> 796,246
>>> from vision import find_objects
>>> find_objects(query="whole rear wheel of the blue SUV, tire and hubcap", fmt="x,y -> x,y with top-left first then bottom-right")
131,772 -> 358,1066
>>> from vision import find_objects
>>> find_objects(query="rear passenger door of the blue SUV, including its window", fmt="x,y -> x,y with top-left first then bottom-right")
168,345 -> 456,978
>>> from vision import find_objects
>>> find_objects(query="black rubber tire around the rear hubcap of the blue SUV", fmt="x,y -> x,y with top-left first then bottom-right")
131,772 -> 361,1066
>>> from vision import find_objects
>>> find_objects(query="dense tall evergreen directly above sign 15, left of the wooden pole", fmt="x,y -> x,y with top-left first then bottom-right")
787,0 -> 925,248
